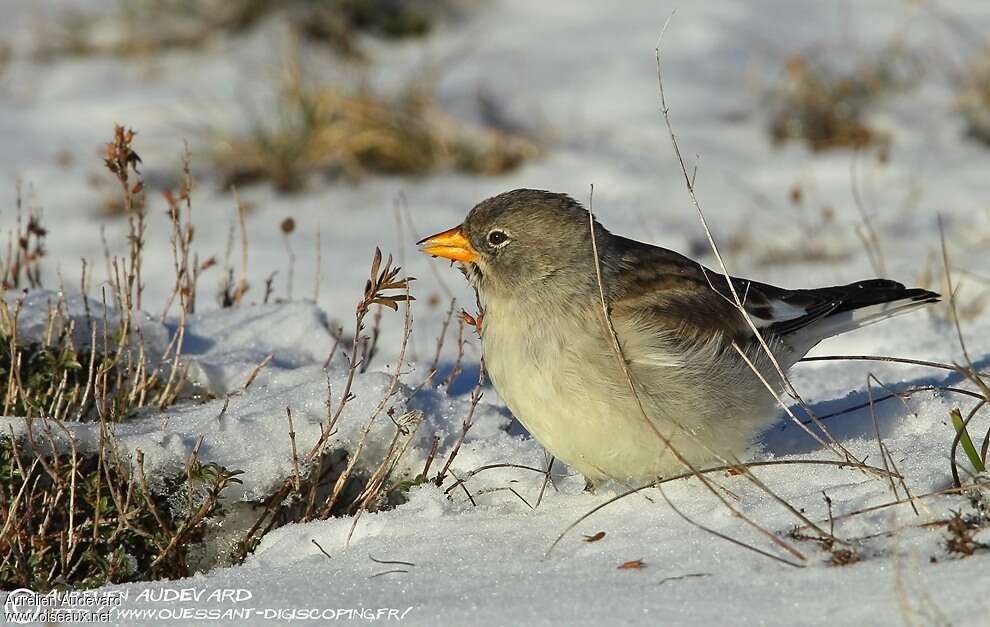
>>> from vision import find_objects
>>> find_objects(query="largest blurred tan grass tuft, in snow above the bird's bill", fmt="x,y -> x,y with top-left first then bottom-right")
213,64 -> 540,191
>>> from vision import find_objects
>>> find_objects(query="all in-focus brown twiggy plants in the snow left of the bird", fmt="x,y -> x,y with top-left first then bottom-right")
0,122 -> 436,591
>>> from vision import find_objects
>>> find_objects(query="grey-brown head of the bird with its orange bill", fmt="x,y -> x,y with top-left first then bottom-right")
420,189 -> 608,295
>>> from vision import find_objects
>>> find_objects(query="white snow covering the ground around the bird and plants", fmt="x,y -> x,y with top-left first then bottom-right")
0,0 -> 990,625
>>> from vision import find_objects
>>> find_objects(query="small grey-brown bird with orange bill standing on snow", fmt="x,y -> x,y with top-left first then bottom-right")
419,189 -> 939,486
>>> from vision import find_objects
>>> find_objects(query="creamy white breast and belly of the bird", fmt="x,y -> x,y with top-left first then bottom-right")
482,296 -> 774,481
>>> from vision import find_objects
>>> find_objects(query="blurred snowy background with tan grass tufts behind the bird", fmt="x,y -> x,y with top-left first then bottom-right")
0,0 -> 990,366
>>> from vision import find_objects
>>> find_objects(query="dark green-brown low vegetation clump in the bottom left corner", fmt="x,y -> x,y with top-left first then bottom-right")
0,434 -> 245,592
